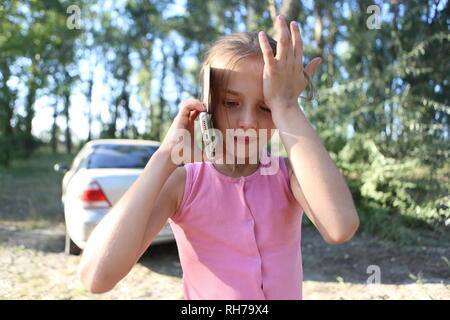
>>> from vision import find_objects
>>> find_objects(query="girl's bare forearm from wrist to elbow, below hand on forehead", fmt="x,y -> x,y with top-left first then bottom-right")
274,105 -> 359,244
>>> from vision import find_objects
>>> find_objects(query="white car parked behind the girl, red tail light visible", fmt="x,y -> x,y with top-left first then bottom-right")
54,139 -> 174,255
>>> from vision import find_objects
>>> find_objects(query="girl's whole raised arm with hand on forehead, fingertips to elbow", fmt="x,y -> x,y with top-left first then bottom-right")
259,16 -> 359,244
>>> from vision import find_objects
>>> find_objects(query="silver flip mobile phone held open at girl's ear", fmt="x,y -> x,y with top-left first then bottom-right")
199,64 -> 216,159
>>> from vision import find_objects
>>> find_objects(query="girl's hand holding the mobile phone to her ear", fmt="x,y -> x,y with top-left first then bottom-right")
158,99 -> 206,162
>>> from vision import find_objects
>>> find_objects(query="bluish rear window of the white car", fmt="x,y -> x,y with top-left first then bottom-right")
84,144 -> 158,169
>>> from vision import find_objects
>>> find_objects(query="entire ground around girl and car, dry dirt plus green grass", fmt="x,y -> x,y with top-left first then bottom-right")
0,152 -> 450,299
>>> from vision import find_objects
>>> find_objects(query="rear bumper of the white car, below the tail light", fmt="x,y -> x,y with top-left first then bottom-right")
64,207 -> 175,249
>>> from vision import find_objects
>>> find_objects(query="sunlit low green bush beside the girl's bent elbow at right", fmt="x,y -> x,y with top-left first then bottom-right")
331,134 -> 450,241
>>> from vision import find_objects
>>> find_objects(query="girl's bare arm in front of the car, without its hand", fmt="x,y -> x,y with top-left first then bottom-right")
78,151 -> 179,293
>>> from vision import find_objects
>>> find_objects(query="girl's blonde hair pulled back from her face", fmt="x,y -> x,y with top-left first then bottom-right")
199,32 -> 316,127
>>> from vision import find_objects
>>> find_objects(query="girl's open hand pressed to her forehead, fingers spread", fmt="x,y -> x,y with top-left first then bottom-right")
259,15 -> 322,113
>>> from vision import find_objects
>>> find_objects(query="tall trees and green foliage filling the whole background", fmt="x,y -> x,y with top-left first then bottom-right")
0,0 -> 450,245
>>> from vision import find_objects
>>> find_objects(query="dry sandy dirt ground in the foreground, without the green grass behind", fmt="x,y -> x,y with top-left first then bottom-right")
0,223 -> 450,300
